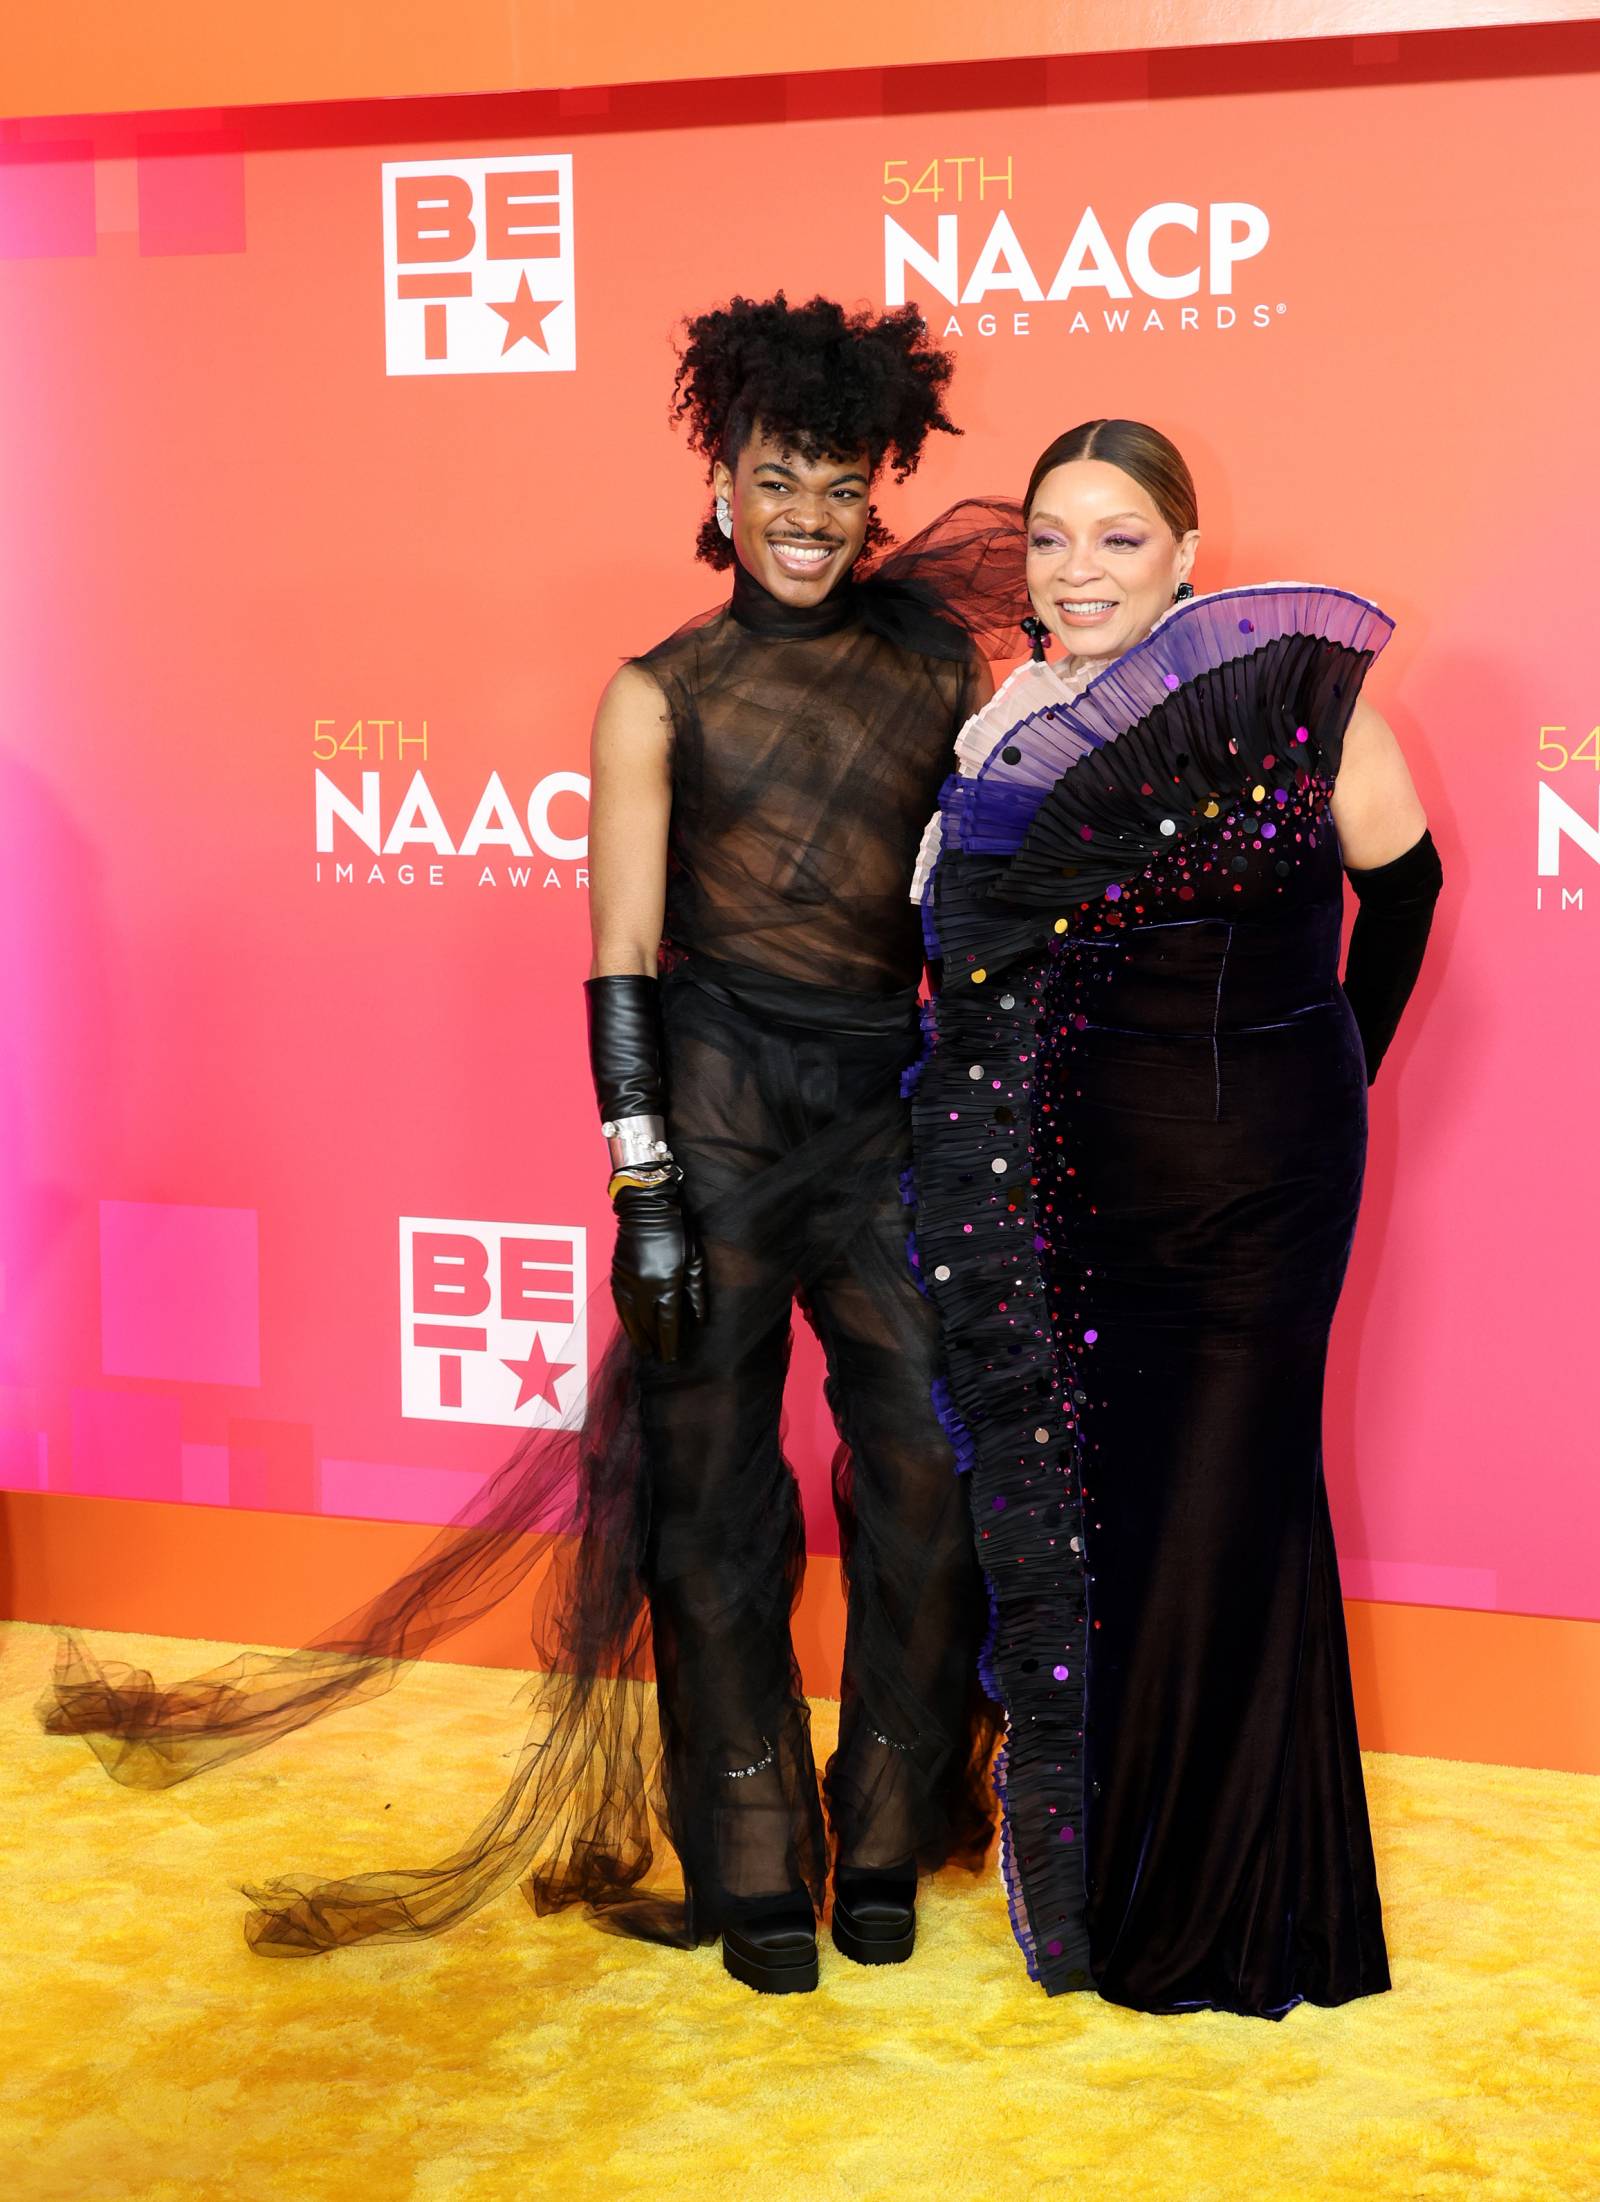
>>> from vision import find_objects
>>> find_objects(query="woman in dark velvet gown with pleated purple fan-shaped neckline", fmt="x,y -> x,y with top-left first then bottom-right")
916,421 -> 1439,2017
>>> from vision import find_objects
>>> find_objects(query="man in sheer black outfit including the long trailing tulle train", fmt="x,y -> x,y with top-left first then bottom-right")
44,284 -> 1021,1993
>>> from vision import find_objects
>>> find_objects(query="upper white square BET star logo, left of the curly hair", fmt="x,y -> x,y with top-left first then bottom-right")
383,152 -> 577,374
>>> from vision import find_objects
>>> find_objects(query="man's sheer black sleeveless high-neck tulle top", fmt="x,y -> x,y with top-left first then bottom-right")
636,554 -> 979,993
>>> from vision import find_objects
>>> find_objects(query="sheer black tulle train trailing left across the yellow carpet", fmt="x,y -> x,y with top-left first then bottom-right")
40,1341 -> 699,1955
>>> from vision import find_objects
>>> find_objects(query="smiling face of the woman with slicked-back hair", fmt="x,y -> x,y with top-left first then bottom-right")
1028,458 -> 1199,658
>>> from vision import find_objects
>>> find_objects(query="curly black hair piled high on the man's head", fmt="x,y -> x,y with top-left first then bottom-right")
673,291 -> 960,566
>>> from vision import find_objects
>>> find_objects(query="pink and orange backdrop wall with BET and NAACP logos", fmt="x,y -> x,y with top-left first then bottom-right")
0,31 -> 1600,1616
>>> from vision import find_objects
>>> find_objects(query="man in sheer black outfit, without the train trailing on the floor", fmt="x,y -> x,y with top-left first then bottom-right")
588,295 -> 1007,1993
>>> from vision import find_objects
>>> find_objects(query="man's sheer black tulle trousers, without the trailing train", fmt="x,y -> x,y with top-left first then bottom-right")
640,967 -> 993,1936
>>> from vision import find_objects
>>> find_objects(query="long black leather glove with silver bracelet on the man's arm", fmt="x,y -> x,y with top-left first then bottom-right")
583,973 -> 706,1361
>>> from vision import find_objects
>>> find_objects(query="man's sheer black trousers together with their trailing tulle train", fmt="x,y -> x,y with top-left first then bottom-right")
42,973 -> 995,1955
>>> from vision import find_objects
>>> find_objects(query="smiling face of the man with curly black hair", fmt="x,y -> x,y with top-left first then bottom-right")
713,423 -> 872,606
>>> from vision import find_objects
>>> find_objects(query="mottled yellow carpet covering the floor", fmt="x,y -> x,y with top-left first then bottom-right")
0,1625 -> 1600,2202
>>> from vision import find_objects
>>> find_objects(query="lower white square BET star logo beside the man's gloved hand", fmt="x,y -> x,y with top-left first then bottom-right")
401,1216 -> 588,1429
